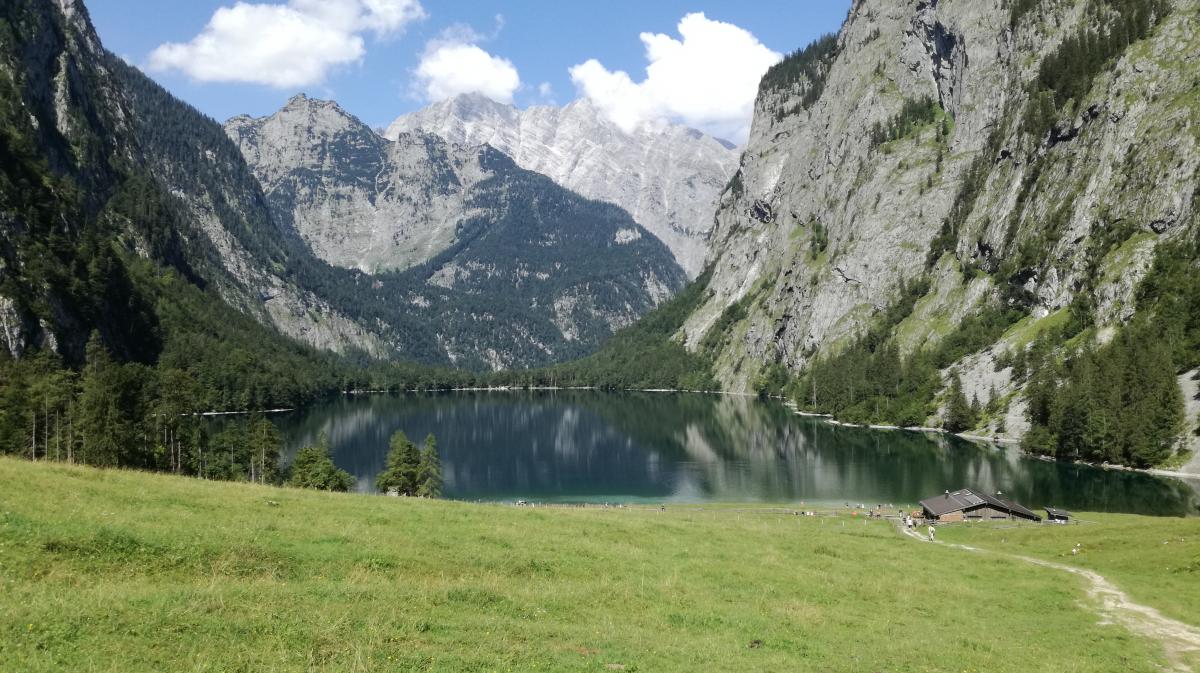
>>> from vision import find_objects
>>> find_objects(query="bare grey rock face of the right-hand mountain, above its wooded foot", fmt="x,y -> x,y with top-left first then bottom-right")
685,0 -> 1200,415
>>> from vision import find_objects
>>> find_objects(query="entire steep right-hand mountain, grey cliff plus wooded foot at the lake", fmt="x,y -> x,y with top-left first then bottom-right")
683,0 -> 1200,464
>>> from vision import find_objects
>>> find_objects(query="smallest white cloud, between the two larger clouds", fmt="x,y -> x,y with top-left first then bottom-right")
416,29 -> 521,103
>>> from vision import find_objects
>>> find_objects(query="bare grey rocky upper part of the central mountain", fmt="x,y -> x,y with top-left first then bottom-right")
226,95 -> 488,272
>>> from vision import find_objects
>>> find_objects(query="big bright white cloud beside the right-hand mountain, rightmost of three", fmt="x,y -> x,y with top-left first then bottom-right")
570,13 -> 782,142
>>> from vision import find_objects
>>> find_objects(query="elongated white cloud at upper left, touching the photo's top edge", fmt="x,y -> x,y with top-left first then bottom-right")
149,0 -> 425,89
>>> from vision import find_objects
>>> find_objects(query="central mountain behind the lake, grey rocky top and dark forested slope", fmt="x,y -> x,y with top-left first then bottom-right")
226,95 -> 685,369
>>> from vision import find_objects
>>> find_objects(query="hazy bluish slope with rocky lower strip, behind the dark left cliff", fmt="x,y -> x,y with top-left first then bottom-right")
112,77 -> 398,357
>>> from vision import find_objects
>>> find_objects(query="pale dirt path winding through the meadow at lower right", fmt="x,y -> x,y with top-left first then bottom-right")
898,525 -> 1200,673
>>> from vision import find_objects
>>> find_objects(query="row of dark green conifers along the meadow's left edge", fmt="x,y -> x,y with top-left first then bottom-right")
0,336 -> 283,483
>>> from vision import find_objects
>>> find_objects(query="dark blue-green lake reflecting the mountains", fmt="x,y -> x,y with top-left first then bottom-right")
275,391 -> 1200,515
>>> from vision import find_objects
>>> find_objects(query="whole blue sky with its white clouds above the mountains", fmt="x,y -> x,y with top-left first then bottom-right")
86,0 -> 850,143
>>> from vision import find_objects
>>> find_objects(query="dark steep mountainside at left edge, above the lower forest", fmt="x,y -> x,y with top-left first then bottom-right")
0,0 -> 364,360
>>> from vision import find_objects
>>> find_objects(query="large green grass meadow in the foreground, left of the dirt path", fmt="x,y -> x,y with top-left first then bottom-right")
0,459 -> 1196,673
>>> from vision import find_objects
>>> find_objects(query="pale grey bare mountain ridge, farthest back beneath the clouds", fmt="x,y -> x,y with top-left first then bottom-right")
384,94 -> 738,278
